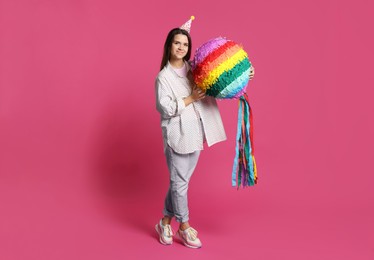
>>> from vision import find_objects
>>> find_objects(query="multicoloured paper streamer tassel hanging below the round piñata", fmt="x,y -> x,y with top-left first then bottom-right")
231,93 -> 257,189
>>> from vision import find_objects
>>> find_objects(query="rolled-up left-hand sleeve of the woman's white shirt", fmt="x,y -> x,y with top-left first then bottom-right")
156,78 -> 186,117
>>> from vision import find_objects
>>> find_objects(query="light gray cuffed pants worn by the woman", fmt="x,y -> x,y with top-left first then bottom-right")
163,145 -> 200,223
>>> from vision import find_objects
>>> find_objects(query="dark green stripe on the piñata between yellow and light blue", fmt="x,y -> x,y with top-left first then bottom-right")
206,57 -> 251,97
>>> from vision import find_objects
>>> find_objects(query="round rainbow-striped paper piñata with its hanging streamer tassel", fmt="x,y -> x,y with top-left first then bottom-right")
192,37 -> 257,188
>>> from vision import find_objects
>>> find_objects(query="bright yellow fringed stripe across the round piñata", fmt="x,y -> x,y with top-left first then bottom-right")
197,49 -> 248,91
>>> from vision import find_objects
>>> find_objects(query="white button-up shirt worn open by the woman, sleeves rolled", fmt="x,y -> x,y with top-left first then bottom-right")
156,62 -> 226,154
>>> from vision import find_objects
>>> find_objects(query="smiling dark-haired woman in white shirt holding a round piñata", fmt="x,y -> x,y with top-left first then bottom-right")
155,22 -> 253,248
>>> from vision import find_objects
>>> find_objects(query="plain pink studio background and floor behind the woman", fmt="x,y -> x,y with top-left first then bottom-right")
0,0 -> 374,260
